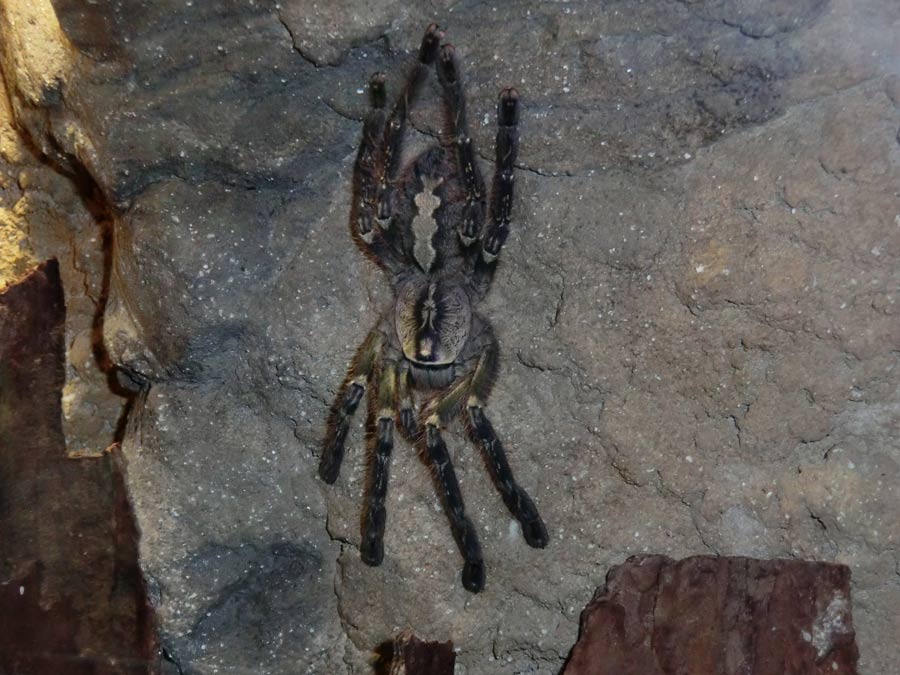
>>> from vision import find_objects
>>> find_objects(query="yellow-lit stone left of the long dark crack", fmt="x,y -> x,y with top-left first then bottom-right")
0,0 -> 124,457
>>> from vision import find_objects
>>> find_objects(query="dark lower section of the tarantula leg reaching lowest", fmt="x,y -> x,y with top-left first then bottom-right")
425,424 -> 484,593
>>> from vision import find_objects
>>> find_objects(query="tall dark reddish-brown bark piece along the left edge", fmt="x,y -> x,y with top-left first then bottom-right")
0,260 -> 154,675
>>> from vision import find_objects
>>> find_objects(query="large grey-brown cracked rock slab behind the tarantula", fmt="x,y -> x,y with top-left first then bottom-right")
4,0 -> 900,675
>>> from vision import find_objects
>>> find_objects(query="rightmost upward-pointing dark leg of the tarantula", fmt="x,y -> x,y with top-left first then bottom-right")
473,88 -> 519,296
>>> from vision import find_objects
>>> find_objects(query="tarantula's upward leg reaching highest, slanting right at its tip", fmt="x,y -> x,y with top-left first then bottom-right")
378,23 -> 443,221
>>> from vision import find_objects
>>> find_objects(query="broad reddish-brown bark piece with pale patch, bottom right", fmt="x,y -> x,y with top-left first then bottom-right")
563,555 -> 858,675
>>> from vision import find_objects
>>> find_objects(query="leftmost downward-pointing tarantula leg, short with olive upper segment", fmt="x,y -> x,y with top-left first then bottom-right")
319,328 -> 382,484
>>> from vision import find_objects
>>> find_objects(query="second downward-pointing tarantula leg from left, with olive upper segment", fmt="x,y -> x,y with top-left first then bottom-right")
359,360 -> 397,566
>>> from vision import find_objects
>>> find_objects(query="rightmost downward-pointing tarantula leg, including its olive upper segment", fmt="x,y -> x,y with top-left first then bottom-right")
466,343 -> 548,548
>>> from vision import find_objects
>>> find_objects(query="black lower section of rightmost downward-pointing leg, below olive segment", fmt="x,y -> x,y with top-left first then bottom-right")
468,405 -> 547,548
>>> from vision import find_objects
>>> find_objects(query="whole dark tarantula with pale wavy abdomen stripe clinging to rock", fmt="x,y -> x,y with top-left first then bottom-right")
319,24 -> 547,593
